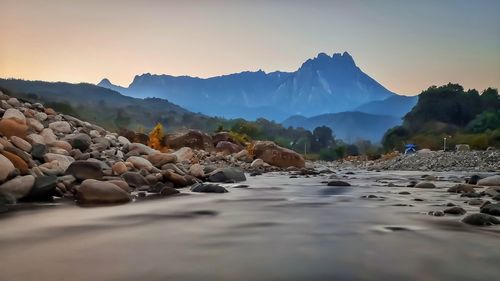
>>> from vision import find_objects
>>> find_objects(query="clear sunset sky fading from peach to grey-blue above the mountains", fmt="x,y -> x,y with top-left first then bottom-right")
0,0 -> 500,95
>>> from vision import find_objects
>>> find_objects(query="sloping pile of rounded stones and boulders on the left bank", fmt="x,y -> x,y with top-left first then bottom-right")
0,92 -> 304,208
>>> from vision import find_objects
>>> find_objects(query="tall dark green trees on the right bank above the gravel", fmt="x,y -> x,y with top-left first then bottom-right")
382,83 -> 500,151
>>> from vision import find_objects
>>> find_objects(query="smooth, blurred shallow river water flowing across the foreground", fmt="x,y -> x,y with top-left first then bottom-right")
0,171 -> 500,281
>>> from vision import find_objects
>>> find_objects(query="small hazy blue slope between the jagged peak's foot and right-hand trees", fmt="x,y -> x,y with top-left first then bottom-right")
355,95 -> 418,118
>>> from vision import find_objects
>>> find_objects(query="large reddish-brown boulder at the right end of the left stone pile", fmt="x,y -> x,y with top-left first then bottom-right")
252,141 -> 305,168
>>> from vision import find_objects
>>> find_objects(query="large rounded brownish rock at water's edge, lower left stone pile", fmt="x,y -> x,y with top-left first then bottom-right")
76,179 -> 132,203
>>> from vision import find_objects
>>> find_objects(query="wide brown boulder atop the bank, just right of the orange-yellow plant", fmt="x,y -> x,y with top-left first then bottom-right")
164,130 -> 213,151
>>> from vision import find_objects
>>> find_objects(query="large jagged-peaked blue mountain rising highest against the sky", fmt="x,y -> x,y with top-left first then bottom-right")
98,52 -> 395,120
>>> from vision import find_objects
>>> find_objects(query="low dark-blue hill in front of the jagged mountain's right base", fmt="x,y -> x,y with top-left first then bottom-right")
282,112 -> 401,143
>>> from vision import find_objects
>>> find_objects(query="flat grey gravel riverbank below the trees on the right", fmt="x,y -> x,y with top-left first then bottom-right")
323,150 -> 500,172
